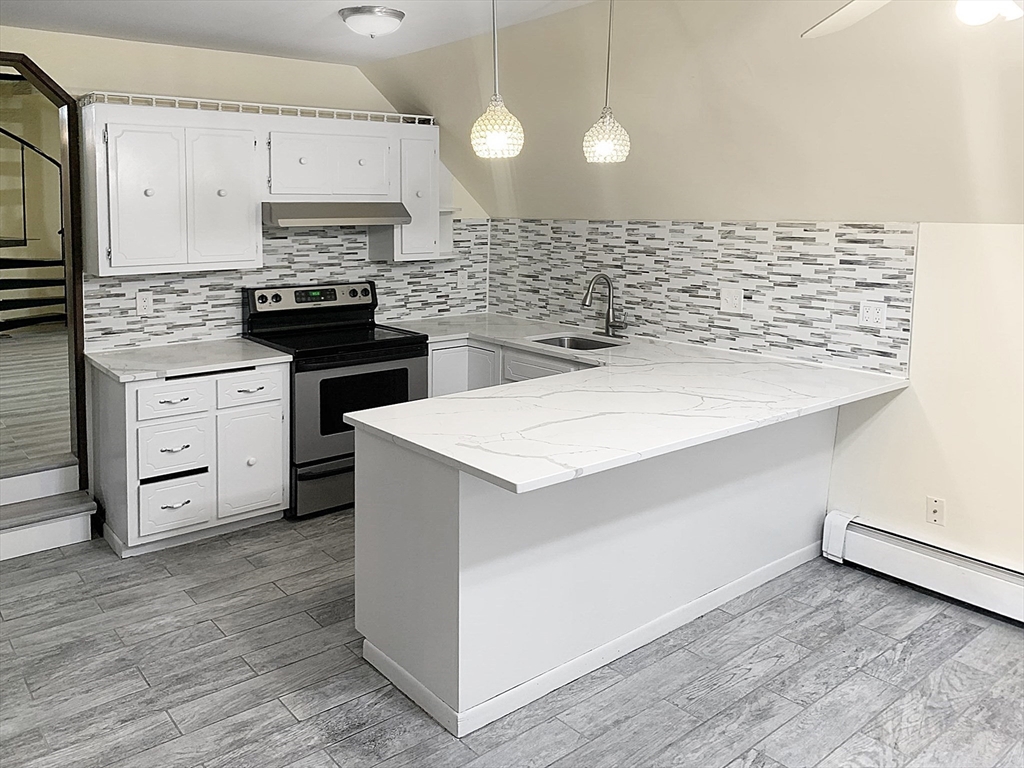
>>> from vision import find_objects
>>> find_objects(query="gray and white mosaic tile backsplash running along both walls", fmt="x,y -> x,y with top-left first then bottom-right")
85,219 -> 918,376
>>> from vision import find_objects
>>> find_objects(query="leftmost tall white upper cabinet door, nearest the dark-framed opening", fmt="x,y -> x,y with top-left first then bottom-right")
106,124 -> 188,266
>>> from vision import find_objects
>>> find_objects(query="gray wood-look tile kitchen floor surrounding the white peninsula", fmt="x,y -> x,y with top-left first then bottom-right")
0,514 -> 1024,768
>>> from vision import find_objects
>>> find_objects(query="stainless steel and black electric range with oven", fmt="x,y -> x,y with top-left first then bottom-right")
242,281 -> 427,517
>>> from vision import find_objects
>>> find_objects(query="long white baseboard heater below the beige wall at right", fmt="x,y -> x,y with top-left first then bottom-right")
821,511 -> 1024,622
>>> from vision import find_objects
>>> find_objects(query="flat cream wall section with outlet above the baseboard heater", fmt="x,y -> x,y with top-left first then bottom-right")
828,224 -> 1024,570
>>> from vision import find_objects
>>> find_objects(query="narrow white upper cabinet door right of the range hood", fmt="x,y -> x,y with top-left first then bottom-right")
396,138 -> 439,258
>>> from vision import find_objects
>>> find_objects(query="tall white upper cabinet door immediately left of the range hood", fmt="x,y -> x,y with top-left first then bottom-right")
185,128 -> 262,262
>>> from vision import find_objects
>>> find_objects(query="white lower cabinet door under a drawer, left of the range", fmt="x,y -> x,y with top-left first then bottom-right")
217,403 -> 285,518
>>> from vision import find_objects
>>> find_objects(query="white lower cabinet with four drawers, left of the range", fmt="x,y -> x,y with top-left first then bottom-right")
89,364 -> 290,556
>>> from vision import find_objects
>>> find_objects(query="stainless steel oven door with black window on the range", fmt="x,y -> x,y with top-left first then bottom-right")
292,356 -> 427,465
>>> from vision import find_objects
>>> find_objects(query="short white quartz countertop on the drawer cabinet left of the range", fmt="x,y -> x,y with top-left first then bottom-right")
85,338 -> 292,383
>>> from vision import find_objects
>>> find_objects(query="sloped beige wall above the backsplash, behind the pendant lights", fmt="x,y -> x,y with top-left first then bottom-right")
362,0 -> 1024,223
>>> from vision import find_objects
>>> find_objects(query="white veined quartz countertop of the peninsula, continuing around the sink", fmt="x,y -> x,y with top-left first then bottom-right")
345,314 -> 909,493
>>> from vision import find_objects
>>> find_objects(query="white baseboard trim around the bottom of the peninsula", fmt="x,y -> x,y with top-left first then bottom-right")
362,542 -> 821,737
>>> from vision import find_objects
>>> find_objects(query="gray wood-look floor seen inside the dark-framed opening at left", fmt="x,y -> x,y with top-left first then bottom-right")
0,324 -> 75,477
